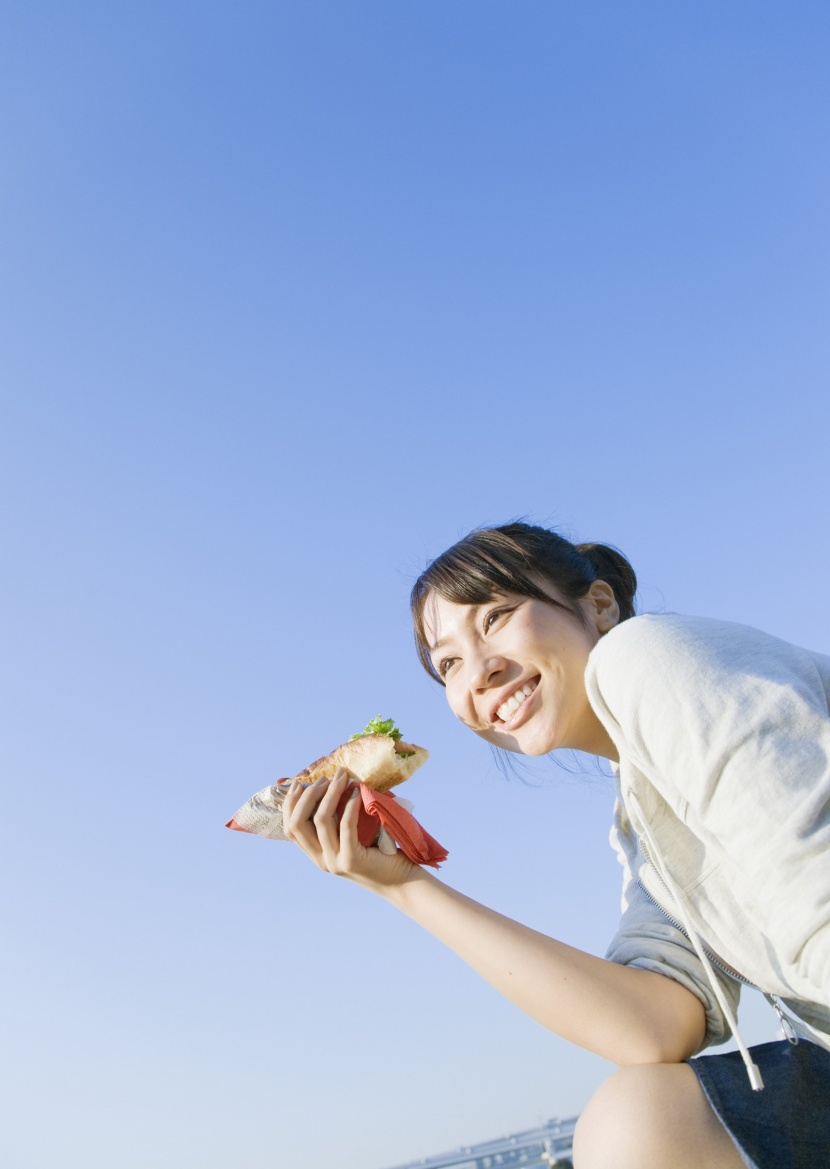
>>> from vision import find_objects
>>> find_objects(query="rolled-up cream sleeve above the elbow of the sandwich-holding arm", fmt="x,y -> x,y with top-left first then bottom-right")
606,800 -> 740,1047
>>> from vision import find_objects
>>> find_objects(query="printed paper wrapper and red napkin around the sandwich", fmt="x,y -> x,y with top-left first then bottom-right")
226,780 -> 448,869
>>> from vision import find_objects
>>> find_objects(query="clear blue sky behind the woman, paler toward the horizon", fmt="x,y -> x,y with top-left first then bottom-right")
0,0 -> 830,1169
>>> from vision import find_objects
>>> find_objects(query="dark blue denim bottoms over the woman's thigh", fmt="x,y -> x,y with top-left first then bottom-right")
689,1039 -> 830,1169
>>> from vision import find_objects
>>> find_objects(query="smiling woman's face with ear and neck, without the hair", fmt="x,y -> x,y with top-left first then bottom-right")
424,581 -> 620,759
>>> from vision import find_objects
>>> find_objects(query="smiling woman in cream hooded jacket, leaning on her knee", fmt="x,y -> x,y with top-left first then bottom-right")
283,524 -> 830,1169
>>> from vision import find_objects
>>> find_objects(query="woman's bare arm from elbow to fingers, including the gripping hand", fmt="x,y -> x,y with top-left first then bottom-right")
283,773 -> 705,1065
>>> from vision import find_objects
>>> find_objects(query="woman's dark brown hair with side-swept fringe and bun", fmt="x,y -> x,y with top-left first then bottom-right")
410,520 -> 637,685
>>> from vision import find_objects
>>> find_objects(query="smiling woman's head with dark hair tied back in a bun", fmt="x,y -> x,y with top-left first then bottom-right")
411,524 -> 637,760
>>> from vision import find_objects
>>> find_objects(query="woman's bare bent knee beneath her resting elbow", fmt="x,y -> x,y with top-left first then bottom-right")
574,1064 -> 746,1169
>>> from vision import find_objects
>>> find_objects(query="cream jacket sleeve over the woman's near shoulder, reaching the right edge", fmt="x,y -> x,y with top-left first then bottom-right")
586,615 -> 830,1005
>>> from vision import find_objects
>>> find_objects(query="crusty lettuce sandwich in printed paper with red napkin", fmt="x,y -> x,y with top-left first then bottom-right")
226,714 -> 448,869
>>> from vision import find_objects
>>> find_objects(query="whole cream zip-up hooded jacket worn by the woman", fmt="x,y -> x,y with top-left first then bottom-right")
586,614 -> 830,1080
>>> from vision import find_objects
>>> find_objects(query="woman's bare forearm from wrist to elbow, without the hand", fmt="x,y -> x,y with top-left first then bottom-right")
378,869 -> 705,1065
